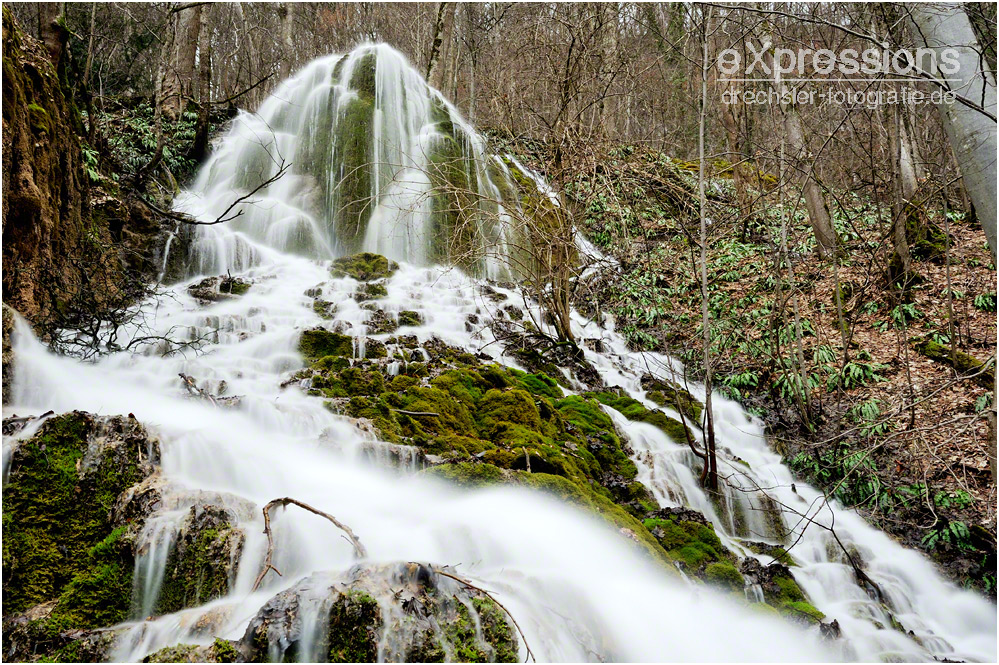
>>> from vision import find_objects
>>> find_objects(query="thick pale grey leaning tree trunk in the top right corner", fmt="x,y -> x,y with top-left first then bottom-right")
906,4 -> 996,257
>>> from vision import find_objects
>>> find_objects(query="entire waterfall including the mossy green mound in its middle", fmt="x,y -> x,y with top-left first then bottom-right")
4,45 -> 996,662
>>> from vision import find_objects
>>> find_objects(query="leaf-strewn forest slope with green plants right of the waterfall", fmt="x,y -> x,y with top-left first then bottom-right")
504,141 -> 996,597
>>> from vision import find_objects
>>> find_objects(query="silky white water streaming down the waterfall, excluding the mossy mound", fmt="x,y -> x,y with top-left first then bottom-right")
4,46 -> 996,661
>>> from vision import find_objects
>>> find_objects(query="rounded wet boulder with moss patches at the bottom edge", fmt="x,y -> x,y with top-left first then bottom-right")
240,563 -> 519,663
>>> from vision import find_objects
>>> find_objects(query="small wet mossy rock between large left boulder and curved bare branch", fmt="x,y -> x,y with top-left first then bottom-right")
155,505 -> 245,614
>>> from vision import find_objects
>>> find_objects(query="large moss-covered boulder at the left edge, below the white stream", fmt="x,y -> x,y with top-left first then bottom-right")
3,411 -> 159,629
